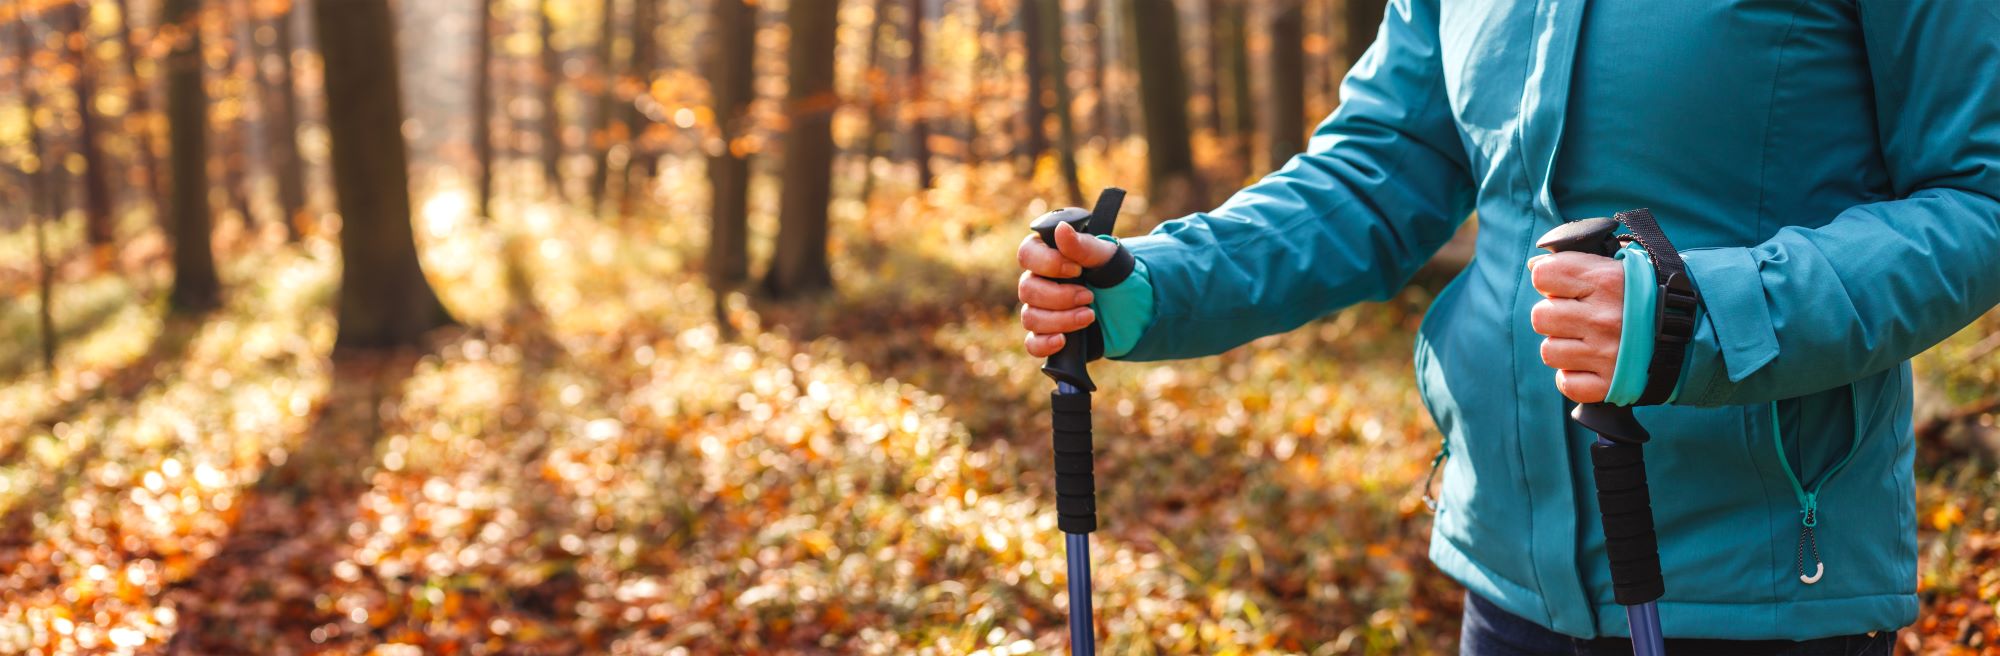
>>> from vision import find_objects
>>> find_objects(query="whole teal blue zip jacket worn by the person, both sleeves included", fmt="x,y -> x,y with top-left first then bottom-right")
1100,0 -> 2000,640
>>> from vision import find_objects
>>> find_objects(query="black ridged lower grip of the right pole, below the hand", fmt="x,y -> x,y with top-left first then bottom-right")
1590,442 -> 1666,606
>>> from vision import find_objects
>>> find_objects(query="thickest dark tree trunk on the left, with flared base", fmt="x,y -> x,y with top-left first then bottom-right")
314,0 -> 452,350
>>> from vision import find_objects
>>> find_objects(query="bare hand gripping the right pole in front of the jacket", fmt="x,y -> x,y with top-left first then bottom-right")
1528,252 -> 1624,404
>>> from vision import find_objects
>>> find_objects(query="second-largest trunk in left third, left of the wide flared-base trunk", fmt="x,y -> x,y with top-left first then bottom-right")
160,0 -> 222,314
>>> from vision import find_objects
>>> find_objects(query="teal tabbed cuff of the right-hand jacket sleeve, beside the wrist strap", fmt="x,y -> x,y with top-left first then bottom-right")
1678,248 -> 1778,406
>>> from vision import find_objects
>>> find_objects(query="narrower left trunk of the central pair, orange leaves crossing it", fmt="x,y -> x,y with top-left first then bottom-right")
708,0 -> 756,290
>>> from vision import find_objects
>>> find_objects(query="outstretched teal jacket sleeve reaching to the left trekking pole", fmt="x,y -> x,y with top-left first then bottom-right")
1124,0 -> 1474,360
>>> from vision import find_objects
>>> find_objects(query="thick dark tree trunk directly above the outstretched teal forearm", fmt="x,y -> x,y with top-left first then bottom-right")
1130,0 -> 1202,216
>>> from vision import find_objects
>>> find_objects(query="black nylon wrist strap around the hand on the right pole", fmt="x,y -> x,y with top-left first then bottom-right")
1614,208 -> 1700,406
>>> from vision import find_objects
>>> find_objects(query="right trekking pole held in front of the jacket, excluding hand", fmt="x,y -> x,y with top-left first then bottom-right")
1534,214 -> 1666,656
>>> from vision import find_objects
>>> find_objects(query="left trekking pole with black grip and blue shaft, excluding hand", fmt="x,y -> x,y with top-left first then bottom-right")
1032,188 -> 1132,656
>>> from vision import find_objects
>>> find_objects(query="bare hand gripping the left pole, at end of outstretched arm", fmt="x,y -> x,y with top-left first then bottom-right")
1018,224 -> 1118,358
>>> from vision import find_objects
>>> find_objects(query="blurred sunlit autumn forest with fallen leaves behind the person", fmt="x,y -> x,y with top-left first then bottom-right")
0,0 -> 2000,654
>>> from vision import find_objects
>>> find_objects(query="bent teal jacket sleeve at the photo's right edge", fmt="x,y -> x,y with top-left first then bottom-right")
1676,0 -> 2000,406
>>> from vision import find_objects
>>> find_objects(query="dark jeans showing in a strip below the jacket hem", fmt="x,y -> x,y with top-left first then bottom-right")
1458,592 -> 1896,656
